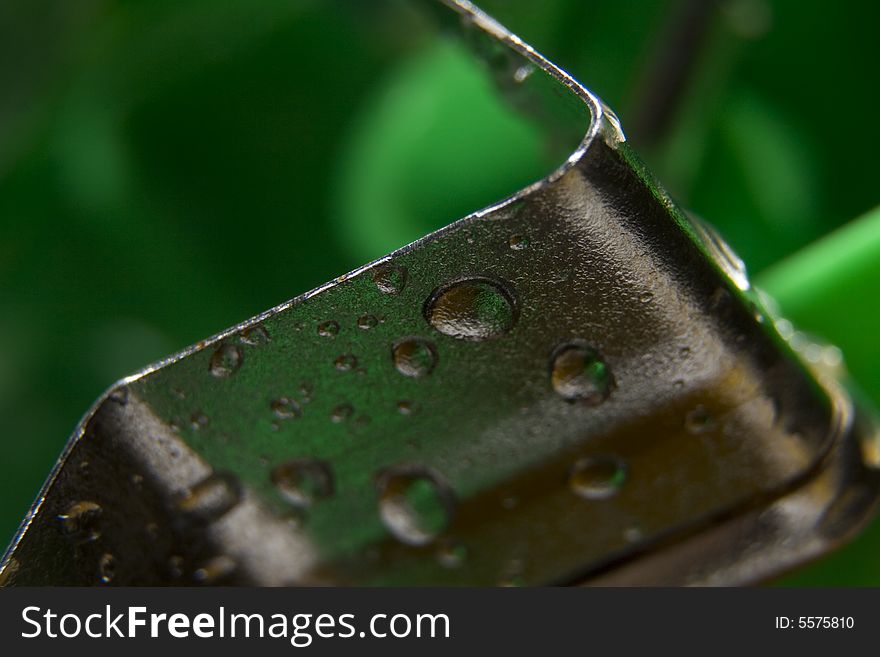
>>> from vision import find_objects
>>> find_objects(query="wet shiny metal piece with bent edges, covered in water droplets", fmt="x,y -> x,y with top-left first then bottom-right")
0,2 -> 880,585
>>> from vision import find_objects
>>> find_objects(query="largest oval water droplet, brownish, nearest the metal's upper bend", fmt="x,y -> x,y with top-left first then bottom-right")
425,278 -> 517,340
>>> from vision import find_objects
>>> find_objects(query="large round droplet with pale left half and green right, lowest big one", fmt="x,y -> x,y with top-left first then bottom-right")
376,465 -> 455,545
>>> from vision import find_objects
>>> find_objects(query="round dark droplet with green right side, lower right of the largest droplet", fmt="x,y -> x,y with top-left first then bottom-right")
550,342 -> 614,406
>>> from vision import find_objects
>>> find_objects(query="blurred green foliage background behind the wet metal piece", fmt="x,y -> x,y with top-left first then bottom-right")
0,0 -> 880,585
